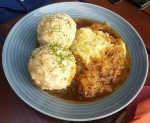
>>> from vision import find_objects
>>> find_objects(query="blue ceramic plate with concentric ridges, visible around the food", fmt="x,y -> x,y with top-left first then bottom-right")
2,2 -> 148,121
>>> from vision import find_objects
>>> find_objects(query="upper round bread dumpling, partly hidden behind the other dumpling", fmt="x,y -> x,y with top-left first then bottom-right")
37,14 -> 76,48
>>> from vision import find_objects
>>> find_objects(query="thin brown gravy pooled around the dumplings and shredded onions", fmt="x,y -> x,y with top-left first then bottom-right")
46,19 -> 131,103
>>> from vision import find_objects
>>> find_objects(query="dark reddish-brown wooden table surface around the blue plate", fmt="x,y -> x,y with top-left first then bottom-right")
0,0 -> 150,123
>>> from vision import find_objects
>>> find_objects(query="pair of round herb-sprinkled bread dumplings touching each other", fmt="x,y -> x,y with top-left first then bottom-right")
28,14 -> 76,90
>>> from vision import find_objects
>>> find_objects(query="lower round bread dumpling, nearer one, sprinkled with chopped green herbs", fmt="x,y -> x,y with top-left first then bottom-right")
28,44 -> 76,90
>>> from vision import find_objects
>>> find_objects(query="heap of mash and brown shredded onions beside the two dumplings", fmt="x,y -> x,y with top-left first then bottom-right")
71,27 -> 127,97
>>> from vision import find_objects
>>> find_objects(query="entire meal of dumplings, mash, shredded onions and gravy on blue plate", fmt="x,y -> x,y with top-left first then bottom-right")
28,14 -> 131,102
